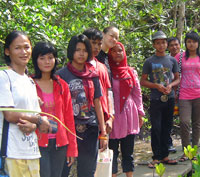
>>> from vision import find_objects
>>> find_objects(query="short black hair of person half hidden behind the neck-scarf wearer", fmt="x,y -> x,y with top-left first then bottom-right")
83,28 -> 103,40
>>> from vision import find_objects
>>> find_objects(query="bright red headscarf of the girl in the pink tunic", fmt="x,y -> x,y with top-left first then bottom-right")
108,42 -> 136,112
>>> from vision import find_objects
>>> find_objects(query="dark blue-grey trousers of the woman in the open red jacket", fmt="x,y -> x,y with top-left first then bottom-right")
40,139 -> 67,177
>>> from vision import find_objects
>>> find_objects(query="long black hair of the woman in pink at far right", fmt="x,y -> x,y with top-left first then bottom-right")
185,31 -> 200,60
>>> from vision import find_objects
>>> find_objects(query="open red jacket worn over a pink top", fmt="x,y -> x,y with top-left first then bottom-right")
36,76 -> 78,157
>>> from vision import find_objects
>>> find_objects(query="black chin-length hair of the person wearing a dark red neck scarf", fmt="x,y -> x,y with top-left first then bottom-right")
67,34 -> 92,61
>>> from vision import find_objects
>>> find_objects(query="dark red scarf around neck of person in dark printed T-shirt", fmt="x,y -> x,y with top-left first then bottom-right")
67,62 -> 98,109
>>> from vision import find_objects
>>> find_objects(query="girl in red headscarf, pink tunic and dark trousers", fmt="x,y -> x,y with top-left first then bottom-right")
108,42 -> 144,177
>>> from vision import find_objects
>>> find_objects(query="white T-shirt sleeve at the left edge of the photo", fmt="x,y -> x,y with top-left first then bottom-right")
0,71 -> 14,107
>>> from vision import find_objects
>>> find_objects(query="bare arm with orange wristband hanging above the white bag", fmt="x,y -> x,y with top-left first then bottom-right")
94,98 -> 108,151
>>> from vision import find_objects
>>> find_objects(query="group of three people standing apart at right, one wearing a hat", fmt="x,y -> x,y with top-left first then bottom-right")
141,31 -> 200,168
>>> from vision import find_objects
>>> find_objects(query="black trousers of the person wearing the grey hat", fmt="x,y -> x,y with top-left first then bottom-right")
150,98 -> 174,160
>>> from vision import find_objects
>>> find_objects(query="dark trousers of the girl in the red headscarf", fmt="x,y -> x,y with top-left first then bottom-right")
109,135 -> 135,174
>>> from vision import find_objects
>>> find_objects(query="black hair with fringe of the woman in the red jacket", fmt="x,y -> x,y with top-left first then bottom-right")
32,42 -> 58,80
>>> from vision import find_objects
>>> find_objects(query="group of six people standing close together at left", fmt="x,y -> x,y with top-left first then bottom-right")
0,26 -> 144,177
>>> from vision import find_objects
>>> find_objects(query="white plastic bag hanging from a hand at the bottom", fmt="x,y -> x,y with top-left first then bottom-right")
94,148 -> 113,177
